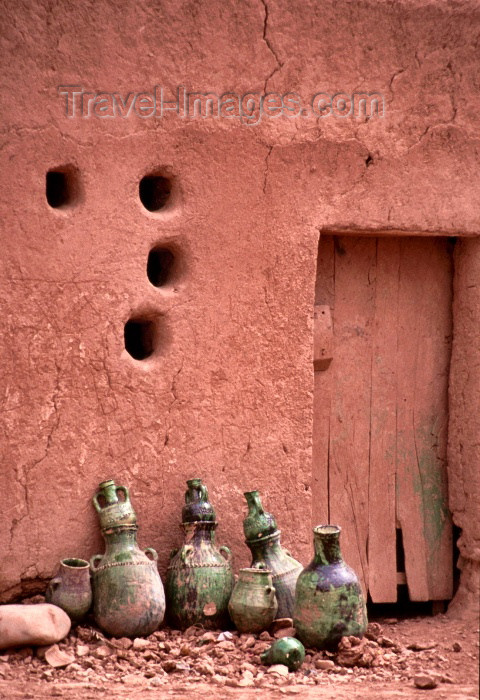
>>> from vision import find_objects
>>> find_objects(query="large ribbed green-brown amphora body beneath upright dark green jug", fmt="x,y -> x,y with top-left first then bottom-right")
165,521 -> 233,630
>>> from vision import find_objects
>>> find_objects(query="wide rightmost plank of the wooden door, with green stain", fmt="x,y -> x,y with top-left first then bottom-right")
397,239 -> 452,600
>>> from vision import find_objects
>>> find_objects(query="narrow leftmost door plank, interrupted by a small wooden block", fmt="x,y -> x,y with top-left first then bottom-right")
312,236 -> 335,525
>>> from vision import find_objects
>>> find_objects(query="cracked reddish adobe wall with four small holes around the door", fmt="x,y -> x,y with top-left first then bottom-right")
0,0 -> 480,612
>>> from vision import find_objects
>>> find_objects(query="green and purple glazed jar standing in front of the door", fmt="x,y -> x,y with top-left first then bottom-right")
293,525 -> 367,649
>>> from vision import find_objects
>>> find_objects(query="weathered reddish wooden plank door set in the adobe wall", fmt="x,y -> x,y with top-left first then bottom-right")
313,236 -> 452,602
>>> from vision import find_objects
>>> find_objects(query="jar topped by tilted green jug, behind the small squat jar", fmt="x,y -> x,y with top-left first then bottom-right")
243,491 -> 303,618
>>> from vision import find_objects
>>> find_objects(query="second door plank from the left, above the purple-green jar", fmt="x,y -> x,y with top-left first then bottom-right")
328,238 -> 376,591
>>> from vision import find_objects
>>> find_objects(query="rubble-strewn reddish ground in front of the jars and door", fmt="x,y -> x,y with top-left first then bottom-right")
0,596 -> 479,700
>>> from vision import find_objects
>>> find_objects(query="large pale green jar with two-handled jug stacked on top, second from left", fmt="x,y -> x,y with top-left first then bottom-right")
90,482 -> 165,637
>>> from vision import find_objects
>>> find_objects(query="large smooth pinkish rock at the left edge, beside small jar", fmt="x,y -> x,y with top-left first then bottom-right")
0,603 -> 71,649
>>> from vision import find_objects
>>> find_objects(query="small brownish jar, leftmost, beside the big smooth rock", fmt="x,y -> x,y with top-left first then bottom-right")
45,559 -> 92,622
